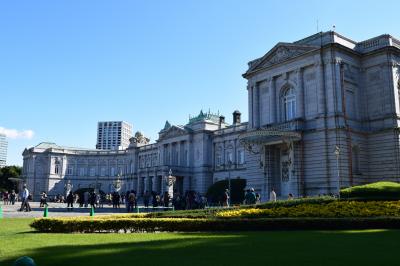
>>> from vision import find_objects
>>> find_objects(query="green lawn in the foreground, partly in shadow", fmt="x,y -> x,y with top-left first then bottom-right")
0,219 -> 400,266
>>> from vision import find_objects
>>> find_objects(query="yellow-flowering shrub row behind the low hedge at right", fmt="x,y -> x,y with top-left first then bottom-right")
215,201 -> 400,218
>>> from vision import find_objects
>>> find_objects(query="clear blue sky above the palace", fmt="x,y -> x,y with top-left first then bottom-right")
0,0 -> 400,165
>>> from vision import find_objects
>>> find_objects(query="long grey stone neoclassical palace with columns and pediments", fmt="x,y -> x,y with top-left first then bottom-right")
23,31 -> 400,200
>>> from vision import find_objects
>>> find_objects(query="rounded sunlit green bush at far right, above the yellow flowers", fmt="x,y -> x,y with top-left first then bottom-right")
340,182 -> 400,200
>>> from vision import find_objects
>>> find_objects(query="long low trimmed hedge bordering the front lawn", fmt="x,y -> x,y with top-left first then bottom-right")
31,217 -> 400,233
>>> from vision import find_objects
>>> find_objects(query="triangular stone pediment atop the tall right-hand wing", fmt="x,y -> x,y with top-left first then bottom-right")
245,43 -> 319,75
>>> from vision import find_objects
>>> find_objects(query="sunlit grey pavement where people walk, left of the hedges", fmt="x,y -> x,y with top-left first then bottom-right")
0,202 -> 172,218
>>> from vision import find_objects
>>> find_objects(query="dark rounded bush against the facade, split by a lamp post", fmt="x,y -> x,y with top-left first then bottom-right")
207,178 -> 247,204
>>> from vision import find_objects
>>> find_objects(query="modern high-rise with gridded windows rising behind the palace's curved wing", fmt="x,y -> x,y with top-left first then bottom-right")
96,121 -> 132,150
